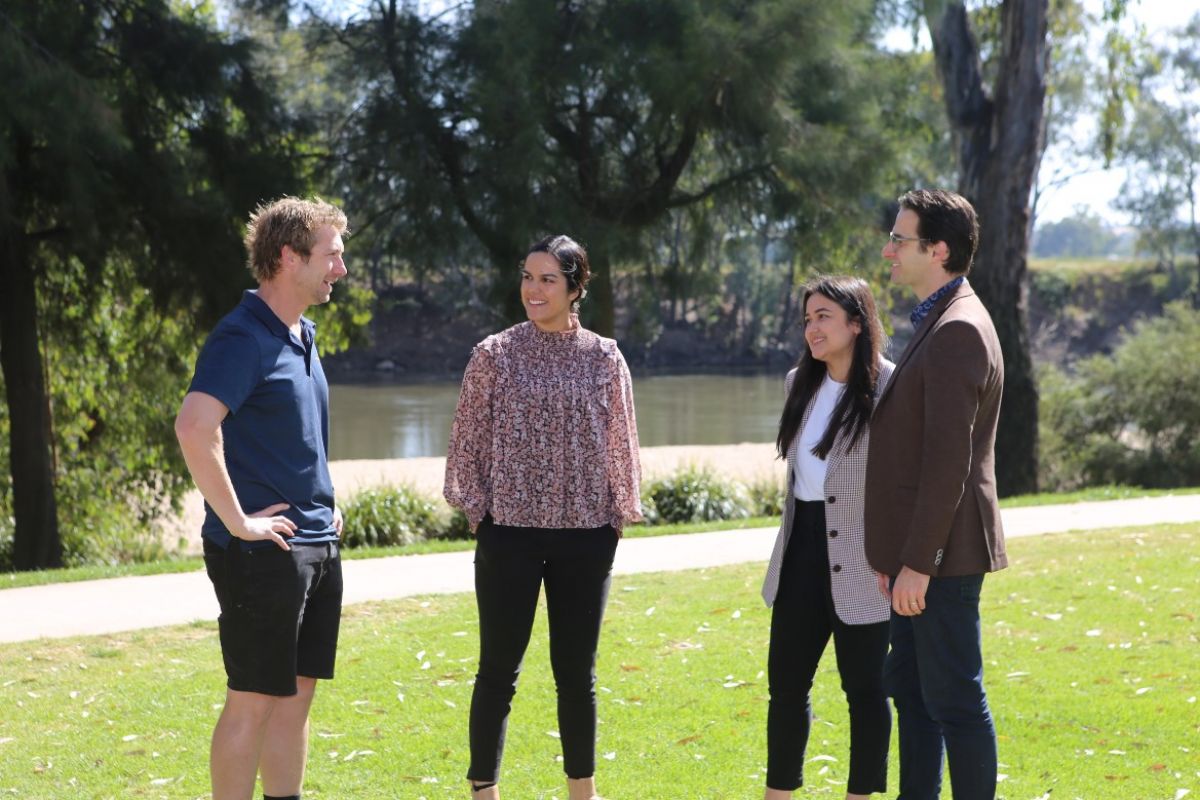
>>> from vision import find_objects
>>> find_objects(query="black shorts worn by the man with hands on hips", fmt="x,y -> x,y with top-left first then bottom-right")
204,539 -> 342,697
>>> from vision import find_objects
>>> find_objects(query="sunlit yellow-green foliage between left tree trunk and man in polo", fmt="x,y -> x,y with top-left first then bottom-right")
0,259 -> 198,565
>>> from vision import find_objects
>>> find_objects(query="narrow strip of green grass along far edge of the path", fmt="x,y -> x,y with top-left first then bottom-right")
9,486 -> 1200,590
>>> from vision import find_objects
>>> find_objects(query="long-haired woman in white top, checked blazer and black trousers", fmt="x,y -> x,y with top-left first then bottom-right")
762,277 -> 894,800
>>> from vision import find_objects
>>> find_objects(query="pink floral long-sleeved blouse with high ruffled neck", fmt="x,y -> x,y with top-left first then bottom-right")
444,314 -> 642,530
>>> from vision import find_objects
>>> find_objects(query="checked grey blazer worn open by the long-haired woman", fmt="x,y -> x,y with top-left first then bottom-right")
762,359 -> 895,625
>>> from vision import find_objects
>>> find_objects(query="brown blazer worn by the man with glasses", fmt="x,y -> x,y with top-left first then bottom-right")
865,281 -> 1008,577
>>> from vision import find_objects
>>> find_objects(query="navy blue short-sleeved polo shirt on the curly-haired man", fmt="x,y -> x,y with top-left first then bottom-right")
188,290 -> 337,547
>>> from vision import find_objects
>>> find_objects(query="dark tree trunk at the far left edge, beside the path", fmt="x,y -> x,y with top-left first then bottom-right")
0,228 -> 62,570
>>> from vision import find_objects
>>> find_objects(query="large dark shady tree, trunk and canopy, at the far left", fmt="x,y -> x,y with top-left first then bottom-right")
0,0 -> 298,569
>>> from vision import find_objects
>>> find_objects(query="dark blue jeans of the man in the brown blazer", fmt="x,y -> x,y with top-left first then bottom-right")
884,575 -> 996,800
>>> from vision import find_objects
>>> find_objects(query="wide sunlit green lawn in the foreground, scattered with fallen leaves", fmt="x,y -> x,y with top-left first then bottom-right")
0,524 -> 1200,800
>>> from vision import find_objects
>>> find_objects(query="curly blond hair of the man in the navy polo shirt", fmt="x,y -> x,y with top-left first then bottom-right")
244,197 -> 349,283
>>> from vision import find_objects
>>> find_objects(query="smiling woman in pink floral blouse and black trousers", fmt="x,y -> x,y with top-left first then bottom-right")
445,236 -> 642,800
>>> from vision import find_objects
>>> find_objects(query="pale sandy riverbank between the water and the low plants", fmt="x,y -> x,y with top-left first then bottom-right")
161,443 -> 784,553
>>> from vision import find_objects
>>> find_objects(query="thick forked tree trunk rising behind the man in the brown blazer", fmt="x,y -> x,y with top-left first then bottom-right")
925,0 -> 1048,497
